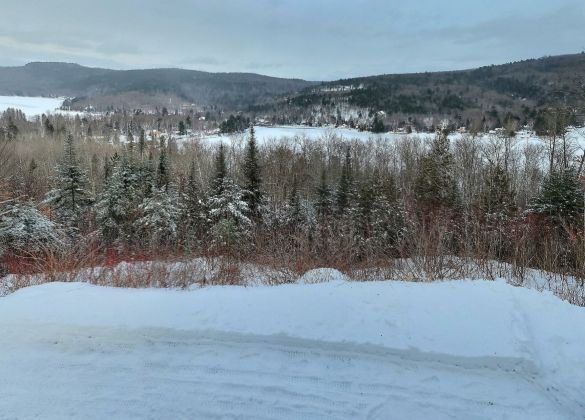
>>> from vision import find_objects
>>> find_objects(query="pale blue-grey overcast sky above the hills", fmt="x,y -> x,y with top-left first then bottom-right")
0,0 -> 585,80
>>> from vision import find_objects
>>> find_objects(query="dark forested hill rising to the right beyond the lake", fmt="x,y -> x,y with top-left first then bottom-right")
260,53 -> 585,129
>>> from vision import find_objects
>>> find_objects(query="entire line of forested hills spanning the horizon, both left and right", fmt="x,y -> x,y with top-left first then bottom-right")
0,53 -> 585,124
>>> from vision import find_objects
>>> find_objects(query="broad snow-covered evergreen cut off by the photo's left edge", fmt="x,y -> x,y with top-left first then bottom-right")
0,202 -> 64,256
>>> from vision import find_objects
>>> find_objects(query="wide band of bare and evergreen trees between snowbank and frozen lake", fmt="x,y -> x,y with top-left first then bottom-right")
0,110 -> 585,292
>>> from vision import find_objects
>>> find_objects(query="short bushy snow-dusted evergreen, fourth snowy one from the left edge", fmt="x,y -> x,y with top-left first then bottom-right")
134,188 -> 180,249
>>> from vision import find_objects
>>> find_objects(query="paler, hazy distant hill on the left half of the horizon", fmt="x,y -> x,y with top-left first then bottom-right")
0,63 -> 313,109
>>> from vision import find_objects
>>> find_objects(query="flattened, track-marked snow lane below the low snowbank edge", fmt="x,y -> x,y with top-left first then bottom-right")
0,324 -> 571,419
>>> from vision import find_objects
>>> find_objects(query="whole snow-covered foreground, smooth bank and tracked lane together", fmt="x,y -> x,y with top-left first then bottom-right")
0,278 -> 585,419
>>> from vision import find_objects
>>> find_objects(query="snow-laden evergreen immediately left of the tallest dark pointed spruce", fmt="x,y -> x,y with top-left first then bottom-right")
207,144 -> 252,246
